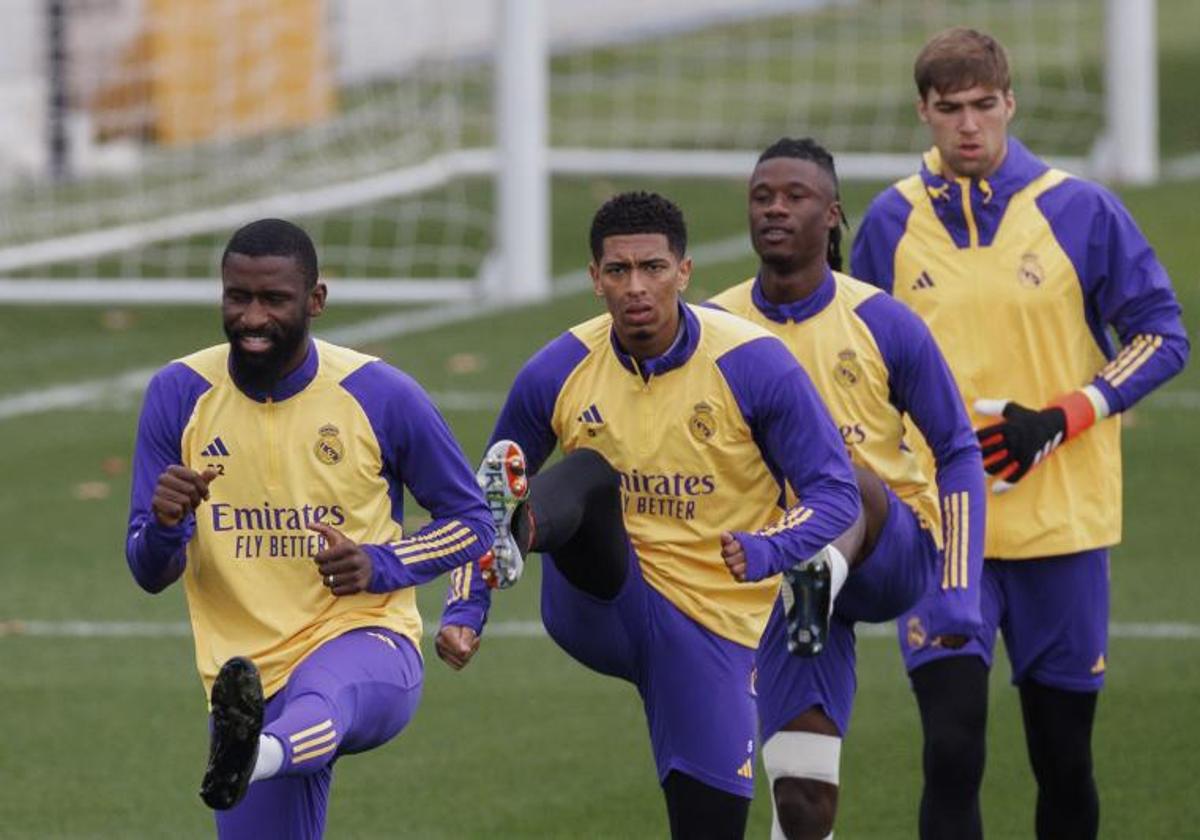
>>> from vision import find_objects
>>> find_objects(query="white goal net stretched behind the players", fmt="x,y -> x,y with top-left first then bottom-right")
0,0 -> 1152,302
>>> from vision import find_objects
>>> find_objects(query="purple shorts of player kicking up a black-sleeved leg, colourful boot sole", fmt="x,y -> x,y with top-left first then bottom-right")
541,550 -> 756,799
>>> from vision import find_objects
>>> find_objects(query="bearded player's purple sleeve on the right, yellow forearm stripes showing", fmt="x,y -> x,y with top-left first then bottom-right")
342,361 -> 496,593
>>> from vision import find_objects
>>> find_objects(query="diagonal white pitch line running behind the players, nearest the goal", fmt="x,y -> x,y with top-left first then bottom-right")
0,236 -> 750,421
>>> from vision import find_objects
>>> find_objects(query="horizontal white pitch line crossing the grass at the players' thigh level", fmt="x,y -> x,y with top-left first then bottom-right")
0,619 -> 1200,641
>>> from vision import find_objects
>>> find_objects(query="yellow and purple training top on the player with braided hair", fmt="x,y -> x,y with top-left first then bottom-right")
709,269 -> 985,624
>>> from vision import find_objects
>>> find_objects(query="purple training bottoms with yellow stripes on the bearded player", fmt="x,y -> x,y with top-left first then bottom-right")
215,628 -> 424,840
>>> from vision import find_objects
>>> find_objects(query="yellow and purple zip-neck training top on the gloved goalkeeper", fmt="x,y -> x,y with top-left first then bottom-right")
851,138 -> 1189,559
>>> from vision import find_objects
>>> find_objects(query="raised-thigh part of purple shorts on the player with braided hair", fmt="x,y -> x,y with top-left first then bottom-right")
834,488 -> 941,623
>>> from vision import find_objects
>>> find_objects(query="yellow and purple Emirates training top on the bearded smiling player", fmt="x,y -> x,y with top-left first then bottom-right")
125,341 -> 494,696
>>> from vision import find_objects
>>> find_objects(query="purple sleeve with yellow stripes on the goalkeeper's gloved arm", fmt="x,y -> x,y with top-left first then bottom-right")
1037,178 -> 1190,413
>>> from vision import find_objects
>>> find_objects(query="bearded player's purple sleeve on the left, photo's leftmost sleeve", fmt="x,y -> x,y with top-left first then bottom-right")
125,361 -> 211,593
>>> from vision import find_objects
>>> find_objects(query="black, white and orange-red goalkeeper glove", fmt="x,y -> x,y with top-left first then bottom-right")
974,391 -> 1106,493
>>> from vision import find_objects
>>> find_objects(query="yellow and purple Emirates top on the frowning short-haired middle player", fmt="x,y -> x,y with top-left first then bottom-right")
442,304 -> 859,648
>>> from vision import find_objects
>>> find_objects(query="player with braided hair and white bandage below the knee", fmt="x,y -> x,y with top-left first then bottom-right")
709,137 -> 984,839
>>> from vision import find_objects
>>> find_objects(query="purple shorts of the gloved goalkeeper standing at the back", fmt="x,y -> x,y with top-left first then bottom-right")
896,548 -> 1109,691
